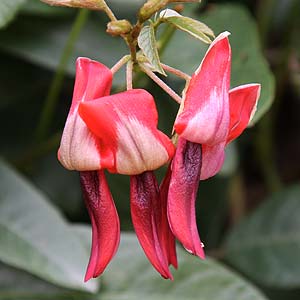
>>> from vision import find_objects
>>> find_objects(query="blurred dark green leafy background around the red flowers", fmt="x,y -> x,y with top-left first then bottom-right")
0,0 -> 300,300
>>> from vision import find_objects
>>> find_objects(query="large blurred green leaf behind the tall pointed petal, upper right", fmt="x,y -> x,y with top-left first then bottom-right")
162,4 -> 275,124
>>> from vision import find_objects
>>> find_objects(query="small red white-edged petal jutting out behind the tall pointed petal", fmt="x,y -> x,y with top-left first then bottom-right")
227,83 -> 261,143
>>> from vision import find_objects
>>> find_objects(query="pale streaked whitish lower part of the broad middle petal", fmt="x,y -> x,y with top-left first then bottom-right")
116,118 -> 169,175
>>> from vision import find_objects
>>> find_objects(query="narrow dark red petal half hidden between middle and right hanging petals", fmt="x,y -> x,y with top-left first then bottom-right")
159,166 -> 178,269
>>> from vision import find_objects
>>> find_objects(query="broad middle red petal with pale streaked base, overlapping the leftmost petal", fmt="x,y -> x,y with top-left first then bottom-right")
79,89 -> 174,175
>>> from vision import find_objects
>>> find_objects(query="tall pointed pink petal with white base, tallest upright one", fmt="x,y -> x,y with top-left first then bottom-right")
174,32 -> 231,145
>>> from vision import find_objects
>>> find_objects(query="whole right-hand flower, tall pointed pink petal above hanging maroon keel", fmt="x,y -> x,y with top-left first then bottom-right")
168,32 -> 260,258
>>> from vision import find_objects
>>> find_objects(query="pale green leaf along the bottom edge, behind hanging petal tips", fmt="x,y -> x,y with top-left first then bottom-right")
0,225 -> 266,300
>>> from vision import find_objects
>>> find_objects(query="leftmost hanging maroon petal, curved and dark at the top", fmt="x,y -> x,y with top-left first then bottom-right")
80,171 -> 120,281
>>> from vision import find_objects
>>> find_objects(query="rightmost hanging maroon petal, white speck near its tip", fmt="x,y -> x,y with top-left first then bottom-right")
168,138 -> 205,258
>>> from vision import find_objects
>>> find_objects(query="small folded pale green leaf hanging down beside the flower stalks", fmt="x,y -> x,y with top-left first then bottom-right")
138,23 -> 166,76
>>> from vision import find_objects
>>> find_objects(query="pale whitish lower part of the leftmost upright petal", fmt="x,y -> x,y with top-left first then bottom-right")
58,109 -> 100,171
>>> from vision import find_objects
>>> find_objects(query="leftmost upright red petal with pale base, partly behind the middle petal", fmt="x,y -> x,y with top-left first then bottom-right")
58,58 -> 112,171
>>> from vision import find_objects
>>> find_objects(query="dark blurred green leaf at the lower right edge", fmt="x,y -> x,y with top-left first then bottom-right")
225,184 -> 300,288
